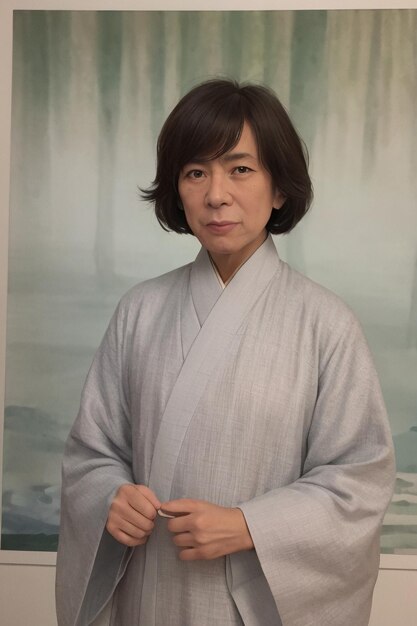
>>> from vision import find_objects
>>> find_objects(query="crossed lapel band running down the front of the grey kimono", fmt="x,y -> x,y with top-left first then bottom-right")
139,237 -> 280,626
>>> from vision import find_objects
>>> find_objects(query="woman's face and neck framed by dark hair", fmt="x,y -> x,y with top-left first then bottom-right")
178,122 -> 285,280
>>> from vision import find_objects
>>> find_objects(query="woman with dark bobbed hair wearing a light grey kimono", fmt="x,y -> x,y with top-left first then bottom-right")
57,80 -> 393,626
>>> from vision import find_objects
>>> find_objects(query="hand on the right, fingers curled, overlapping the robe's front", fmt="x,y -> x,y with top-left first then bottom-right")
161,498 -> 253,561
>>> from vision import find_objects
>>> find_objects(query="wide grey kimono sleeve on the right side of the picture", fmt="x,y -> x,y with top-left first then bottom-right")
239,315 -> 394,626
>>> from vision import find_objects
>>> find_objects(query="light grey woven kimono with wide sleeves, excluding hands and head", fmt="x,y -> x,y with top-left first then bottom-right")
57,237 -> 394,626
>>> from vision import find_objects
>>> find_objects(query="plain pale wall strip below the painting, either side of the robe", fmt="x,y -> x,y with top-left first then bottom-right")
0,565 -> 417,626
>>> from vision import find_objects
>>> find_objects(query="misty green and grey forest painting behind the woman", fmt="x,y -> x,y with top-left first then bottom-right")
1,10 -> 417,554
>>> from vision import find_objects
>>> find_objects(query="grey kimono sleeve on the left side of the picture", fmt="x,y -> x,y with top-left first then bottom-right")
56,304 -> 133,626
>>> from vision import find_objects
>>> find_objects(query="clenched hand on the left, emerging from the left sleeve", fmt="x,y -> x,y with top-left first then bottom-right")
106,484 -> 161,547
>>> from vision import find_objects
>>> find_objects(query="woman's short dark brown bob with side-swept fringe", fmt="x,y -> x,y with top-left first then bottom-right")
141,80 -> 313,234
